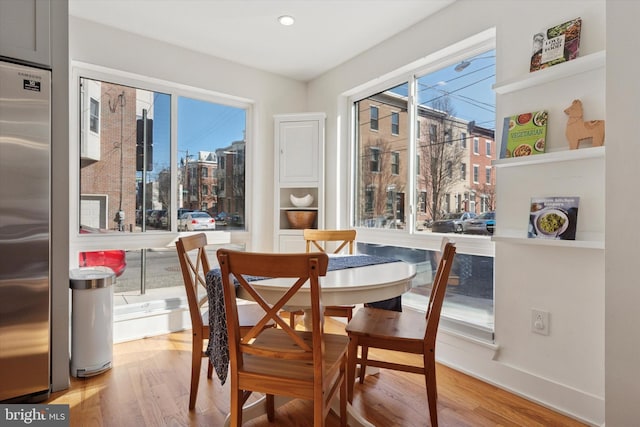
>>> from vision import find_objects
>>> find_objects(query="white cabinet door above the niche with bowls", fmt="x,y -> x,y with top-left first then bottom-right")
279,120 -> 320,184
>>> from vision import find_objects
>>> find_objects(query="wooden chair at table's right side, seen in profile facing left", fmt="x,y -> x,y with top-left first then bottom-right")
346,242 -> 456,427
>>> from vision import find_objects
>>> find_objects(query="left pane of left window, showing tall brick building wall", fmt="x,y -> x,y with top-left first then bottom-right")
78,78 -> 171,232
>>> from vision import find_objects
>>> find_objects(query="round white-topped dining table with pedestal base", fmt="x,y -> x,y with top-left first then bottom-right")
225,261 -> 416,427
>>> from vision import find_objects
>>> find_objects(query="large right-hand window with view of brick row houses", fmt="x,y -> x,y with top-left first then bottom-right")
353,46 -> 497,337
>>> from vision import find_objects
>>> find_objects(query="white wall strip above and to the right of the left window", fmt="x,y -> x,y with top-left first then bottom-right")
69,17 -> 306,251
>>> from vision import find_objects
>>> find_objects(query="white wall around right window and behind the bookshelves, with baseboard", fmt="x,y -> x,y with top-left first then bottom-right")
308,0 -> 611,425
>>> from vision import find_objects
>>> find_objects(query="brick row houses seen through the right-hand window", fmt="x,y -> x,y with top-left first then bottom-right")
356,91 -> 496,231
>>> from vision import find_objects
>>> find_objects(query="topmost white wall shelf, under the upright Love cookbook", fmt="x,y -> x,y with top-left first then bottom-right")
493,50 -> 606,94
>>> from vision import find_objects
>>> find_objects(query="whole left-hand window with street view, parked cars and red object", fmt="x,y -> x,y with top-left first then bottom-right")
71,70 -> 250,303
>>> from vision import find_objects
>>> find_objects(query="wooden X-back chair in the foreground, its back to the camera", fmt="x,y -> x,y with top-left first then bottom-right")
218,249 -> 348,426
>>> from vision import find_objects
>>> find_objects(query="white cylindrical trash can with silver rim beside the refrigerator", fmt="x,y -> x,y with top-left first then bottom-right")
69,267 -> 115,377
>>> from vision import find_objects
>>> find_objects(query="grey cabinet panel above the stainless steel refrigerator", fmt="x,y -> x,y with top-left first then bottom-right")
0,0 -> 51,66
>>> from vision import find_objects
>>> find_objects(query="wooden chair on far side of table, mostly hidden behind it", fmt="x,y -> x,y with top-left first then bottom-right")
289,228 -> 356,327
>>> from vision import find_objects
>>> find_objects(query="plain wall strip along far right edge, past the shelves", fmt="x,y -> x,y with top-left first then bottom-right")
605,0 -> 640,427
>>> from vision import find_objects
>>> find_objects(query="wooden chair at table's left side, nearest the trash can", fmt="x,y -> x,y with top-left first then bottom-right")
176,233 -> 273,410
